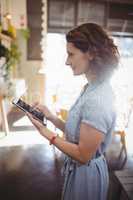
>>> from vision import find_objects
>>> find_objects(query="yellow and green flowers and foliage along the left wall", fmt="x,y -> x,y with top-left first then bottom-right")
0,14 -> 29,96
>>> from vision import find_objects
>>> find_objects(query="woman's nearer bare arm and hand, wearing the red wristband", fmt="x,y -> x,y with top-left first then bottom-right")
28,114 -> 104,164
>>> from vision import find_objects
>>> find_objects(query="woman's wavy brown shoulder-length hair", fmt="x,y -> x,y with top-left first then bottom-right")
66,23 -> 119,79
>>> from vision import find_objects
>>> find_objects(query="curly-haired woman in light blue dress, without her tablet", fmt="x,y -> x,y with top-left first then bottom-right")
28,23 -> 119,200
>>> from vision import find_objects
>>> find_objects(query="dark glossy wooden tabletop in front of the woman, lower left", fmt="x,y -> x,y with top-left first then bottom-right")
0,143 -> 62,200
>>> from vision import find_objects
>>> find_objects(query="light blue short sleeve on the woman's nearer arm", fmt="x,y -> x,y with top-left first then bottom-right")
81,99 -> 113,134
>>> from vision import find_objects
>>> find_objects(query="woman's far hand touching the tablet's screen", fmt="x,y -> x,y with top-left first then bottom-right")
32,102 -> 53,121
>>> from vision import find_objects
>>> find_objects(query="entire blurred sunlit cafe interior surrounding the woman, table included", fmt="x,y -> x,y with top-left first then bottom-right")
0,0 -> 133,200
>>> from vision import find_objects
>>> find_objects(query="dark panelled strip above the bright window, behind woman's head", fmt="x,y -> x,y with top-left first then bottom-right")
48,0 -> 133,36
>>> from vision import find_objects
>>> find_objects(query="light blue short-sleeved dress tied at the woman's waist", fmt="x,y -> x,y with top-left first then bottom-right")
62,81 -> 116,200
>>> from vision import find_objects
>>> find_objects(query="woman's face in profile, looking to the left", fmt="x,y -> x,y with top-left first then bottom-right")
66,42 -> 92,75
